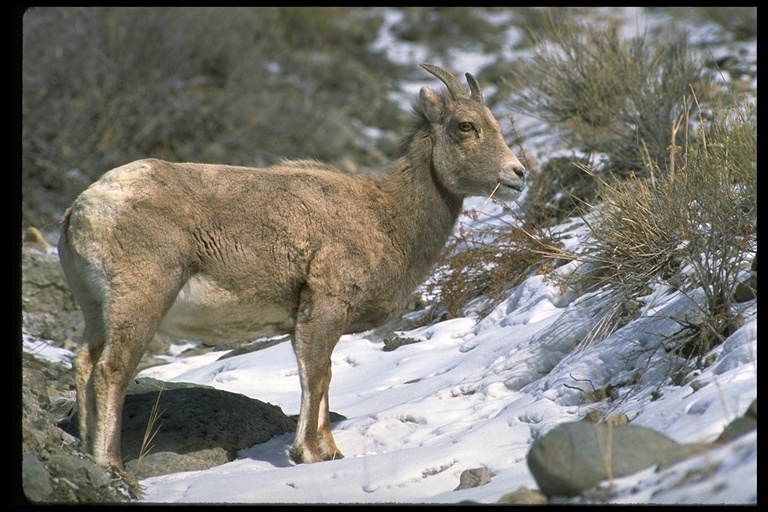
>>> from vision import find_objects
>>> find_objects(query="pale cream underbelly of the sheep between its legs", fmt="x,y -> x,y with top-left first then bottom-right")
157,276 -> 295,345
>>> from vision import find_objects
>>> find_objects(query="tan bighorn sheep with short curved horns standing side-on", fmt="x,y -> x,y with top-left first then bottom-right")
58,64 -> 525,468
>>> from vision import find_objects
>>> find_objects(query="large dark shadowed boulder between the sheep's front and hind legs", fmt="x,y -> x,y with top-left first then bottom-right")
62,378 -> 296,479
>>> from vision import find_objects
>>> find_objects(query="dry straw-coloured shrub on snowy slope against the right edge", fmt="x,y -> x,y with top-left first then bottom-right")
569,95 -> 757,357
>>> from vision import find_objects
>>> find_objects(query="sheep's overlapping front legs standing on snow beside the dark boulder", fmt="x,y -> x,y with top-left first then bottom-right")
290,294 -> 347,464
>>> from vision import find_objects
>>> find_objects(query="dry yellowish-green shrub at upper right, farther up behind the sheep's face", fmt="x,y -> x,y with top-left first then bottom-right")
508,16 -> 706,177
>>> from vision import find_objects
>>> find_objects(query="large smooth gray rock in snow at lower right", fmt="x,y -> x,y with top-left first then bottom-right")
528,421 -> 706,497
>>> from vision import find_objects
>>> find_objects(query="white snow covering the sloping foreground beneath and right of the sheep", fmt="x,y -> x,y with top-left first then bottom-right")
27,195 -> 757,503
